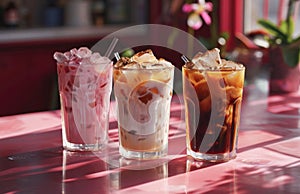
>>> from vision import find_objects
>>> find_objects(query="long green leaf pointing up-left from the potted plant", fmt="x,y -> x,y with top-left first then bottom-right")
258,19 -> 288,43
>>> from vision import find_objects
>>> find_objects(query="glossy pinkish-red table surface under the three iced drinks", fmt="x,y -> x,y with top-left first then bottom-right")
0,81 -> 300,194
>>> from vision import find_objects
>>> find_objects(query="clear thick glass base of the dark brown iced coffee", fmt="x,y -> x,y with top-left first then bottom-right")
187,149 -> 236,162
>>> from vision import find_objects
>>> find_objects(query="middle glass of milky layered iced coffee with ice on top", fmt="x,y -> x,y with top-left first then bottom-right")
114,50 -> 174,159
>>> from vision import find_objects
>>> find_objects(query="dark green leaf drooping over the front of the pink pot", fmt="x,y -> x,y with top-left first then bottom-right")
282,47 -> 300,67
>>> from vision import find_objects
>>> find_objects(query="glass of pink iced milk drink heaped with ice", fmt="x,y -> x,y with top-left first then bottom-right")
54,47 -> 112,151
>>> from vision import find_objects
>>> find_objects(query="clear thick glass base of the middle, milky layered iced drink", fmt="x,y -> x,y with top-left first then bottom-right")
119,146 -> 168,160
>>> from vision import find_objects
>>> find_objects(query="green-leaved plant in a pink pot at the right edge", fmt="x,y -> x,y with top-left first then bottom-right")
258,0 -> 300,93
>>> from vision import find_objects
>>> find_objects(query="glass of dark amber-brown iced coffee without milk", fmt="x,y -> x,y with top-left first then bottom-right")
182,49 -> 245,162
